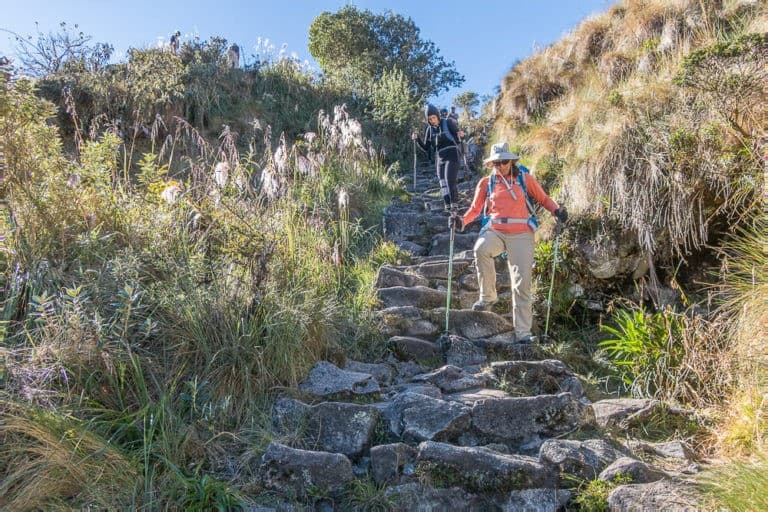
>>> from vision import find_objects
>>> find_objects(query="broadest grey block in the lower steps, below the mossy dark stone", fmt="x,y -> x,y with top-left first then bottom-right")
472,393 -> 591,452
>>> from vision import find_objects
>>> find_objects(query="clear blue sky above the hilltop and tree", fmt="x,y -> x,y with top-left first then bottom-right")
0,0 -> 615,106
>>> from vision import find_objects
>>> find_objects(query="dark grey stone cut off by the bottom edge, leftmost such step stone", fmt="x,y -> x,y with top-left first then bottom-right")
386,482 -> 500,512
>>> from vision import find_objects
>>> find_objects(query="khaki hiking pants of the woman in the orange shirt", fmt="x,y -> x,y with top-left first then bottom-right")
475,229 -> 534,337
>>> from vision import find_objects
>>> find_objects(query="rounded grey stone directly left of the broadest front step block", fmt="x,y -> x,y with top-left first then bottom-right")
382,393 -> 470,441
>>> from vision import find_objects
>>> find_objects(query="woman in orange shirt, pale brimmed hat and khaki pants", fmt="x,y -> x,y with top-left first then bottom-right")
451,142 -> 568,343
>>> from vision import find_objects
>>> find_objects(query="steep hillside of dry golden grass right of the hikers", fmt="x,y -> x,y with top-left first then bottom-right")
494,0 -> 768,460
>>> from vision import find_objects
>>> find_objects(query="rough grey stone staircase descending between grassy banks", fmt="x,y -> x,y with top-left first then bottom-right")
254,162 -> 695,511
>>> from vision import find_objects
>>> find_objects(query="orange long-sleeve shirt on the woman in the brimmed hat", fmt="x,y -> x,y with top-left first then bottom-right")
461,169 -> 559,234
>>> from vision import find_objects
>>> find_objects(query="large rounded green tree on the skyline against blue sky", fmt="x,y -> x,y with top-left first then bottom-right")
309,6 -> 464,98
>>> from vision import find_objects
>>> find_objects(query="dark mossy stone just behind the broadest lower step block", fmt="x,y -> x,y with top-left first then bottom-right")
491,359 -> 584,398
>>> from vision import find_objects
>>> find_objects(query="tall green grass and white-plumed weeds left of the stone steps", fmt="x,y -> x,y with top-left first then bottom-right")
0,53 -> 400,510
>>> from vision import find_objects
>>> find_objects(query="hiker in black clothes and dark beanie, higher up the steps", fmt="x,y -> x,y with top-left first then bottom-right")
411,103 -> 464,210
